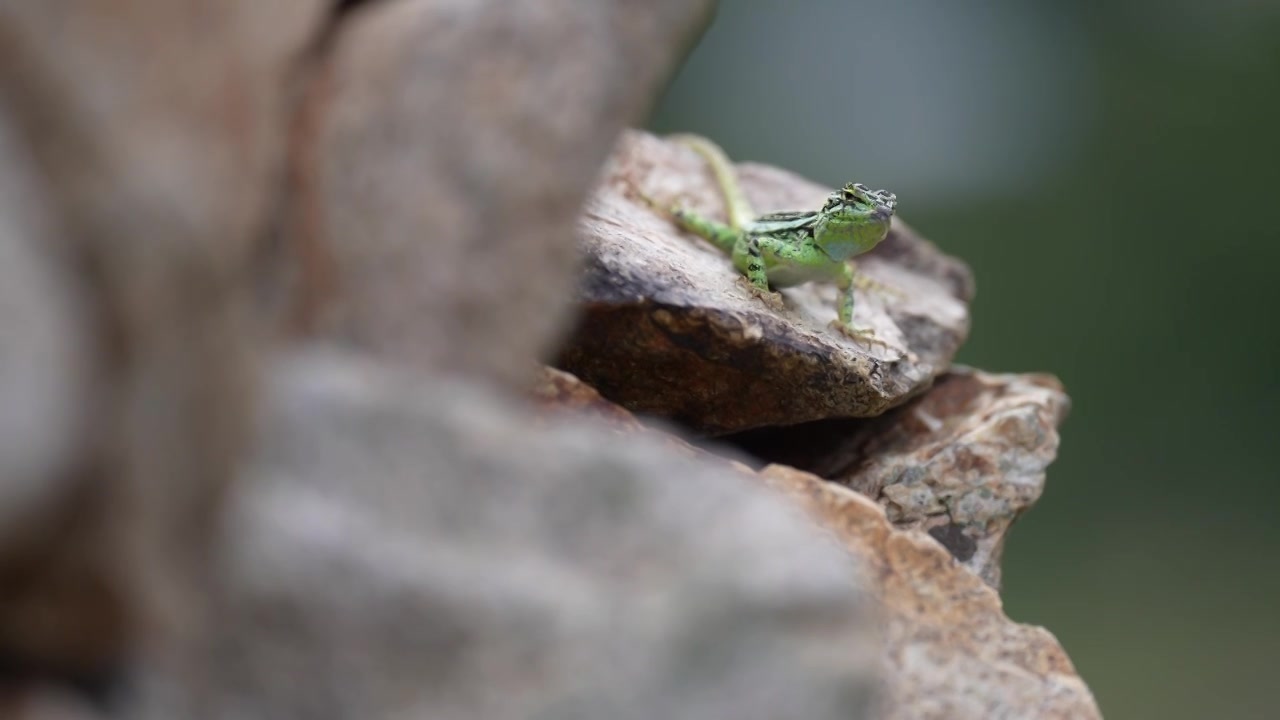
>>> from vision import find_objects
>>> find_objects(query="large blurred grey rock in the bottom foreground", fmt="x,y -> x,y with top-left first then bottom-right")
141,356 -> 881,720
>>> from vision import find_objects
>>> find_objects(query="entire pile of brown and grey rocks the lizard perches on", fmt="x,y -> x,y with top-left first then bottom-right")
0,0 -> 1097,720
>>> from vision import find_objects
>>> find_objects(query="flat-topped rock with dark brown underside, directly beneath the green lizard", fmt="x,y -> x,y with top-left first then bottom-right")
556,132 -> 973,434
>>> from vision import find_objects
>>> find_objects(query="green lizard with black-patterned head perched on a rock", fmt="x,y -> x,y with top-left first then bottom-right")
645,135 -> 897,347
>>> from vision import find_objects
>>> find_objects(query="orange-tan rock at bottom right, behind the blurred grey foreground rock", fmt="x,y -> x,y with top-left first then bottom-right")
762,465 -> 1102,720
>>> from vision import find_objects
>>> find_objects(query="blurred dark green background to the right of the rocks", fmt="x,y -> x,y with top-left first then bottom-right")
652,0 -> 1280,719
